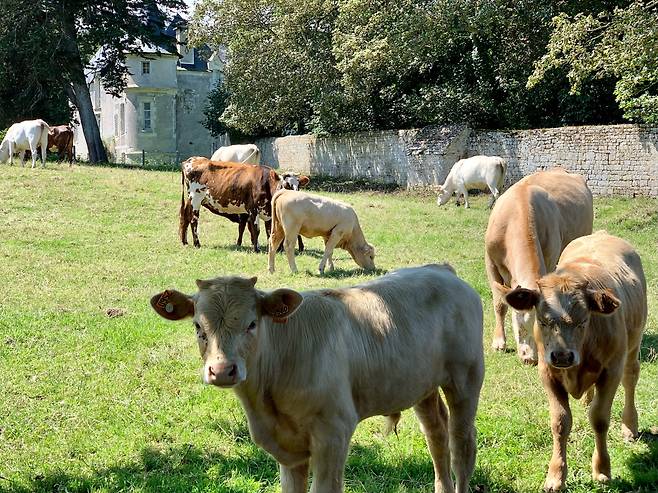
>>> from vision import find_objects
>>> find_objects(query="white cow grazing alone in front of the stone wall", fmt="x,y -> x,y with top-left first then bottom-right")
436,156 -> 507,209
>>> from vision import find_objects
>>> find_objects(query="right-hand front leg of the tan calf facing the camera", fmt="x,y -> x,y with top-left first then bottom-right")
589,368 -> 622,481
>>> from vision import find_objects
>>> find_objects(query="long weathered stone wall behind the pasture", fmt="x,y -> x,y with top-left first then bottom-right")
256,125 -> 658,196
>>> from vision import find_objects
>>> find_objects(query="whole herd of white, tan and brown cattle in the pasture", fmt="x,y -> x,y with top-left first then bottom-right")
0,120 -> 647,493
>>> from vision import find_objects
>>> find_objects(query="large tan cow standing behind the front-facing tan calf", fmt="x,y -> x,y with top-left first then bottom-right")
485,169 -> 594,364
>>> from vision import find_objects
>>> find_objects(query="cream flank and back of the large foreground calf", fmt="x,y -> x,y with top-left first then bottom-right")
261,265 -> 483,419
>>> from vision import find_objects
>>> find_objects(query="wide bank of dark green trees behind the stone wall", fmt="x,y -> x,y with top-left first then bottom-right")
192,0 -> 621,134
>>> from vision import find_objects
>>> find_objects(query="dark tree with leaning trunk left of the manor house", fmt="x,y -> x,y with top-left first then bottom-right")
0,0 -> 184,162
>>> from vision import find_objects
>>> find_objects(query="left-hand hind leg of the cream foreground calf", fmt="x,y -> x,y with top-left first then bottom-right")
414,390 -> 454,493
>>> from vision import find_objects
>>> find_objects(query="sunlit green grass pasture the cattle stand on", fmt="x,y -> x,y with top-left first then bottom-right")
0,163 -> 658,492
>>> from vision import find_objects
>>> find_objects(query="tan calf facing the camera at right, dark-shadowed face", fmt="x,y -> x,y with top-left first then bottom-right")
506,231 -> 647,491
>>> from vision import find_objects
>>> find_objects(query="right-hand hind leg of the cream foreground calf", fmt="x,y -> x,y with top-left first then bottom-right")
443,360 -> 484,493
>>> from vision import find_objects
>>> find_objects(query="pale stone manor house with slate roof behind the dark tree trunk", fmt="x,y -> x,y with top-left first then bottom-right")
74,16 -> 225,163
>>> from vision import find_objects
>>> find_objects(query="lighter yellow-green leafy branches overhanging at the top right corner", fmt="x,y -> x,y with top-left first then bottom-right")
528,0 -> 658,124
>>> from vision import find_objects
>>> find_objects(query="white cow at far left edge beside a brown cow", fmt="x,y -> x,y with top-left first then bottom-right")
0,120 -> 50,168
